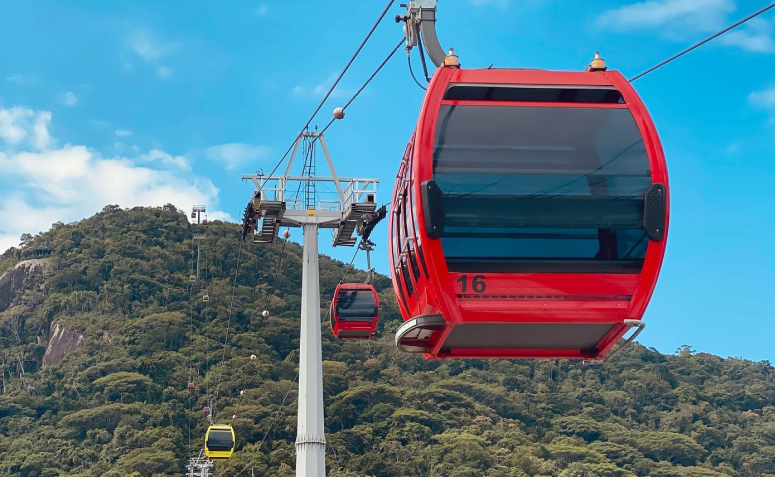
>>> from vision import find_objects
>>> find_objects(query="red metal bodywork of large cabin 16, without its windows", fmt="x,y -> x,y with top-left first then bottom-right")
389,68 -> 669,359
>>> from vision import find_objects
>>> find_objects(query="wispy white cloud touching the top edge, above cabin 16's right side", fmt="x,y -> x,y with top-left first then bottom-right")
598,0 -> 735,34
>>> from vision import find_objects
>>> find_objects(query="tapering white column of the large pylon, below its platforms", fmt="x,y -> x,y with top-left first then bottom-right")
296,222 -> 326,477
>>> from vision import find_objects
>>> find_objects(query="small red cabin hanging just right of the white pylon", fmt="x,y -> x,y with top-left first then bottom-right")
330,283 -> 379,339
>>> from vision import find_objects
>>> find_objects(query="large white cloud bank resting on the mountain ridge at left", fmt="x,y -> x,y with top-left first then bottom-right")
0,107 -> 233,251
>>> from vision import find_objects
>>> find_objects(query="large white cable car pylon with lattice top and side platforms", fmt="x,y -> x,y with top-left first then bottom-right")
242,123 -> 379,477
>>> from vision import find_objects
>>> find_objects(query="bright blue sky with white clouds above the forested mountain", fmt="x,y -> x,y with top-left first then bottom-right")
0,0 -> 775,360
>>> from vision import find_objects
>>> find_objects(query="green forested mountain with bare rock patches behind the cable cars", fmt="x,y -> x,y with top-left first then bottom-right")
0,205 -> 775,477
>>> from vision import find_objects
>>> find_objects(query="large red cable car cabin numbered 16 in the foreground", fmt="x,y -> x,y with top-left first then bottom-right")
389,67 -> 669,359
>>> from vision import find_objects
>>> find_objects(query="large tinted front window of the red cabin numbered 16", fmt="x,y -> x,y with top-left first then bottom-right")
433,105 -> 651,273
